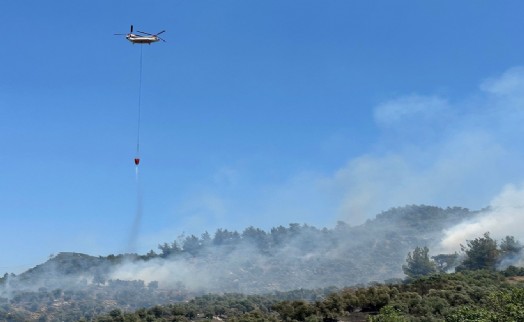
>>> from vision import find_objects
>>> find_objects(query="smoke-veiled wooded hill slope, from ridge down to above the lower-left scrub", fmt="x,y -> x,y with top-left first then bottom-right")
5,206 -> 475,293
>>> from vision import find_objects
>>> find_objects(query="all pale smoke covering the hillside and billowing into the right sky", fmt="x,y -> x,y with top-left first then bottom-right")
112,67 -> 524,286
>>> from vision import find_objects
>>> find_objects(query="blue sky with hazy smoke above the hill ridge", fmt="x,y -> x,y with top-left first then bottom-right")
0,0 -> 524,272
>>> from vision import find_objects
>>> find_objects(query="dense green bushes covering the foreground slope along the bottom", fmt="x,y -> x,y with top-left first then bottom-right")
88,268 -> 524,322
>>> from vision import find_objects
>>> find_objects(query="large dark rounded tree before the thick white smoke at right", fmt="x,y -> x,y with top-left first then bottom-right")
456,232 -> 500,271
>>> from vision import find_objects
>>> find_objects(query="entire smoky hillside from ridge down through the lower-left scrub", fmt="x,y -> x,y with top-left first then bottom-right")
0,206 -> 476,318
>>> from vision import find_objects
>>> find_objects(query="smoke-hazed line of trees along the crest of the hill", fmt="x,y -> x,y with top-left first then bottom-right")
104,205 -> 477,262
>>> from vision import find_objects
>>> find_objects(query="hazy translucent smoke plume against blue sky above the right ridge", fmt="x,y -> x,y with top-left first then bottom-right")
333,67 -> 524,222
